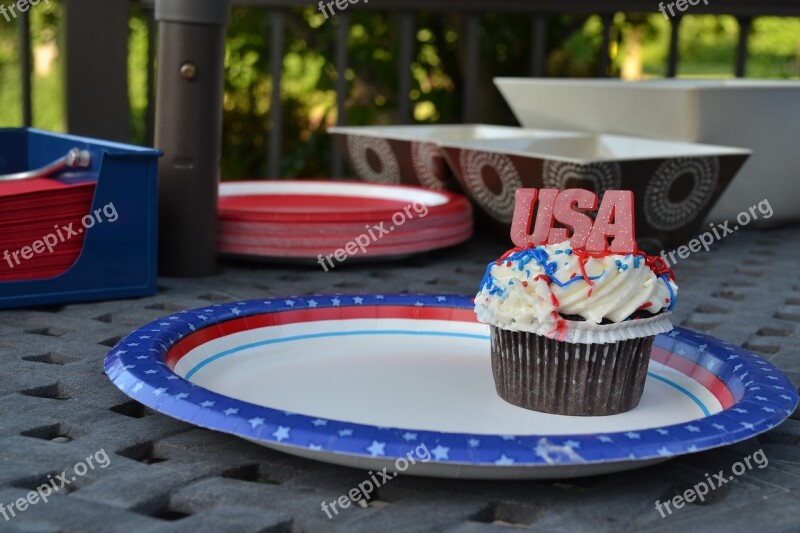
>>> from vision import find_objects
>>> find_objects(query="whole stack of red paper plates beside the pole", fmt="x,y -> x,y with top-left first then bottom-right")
219,181 -> 473,267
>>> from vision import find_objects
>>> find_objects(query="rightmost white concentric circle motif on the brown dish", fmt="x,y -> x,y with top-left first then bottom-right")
644,157 -> 719,231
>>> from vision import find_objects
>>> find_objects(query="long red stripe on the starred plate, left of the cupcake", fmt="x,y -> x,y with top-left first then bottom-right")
165,305 -> 477,369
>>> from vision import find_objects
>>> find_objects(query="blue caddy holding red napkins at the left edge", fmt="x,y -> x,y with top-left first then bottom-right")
0,128 -> 161,309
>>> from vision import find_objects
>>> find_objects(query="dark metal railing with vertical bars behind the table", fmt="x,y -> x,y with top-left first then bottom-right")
14,0 -> 800,177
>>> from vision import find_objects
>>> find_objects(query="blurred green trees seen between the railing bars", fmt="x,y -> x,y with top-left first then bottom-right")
0,2 -> 800,178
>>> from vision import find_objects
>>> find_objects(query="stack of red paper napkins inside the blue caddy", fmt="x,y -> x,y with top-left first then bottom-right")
0,178 -> 95,281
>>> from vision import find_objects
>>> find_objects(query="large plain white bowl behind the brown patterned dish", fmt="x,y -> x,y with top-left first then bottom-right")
495,78 -> 800,225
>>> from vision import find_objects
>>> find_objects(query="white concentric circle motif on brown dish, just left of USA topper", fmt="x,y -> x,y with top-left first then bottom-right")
459,150 -> 522,222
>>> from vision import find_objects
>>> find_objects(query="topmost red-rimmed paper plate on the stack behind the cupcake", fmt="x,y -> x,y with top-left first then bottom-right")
218,181 -> 471,223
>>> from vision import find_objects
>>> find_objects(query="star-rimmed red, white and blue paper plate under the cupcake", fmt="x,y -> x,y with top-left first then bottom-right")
105,295 -> 797,479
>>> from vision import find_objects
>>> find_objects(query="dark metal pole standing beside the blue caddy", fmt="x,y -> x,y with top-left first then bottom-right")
155,0 -> 230,277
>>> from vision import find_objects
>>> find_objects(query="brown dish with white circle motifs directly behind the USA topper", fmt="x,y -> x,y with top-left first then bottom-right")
440,135 -> 750,253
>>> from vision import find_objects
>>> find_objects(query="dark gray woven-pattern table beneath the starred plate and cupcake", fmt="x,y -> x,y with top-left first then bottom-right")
0,228 -> 800,533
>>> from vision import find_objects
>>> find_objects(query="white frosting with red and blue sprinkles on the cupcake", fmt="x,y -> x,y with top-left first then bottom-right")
475,241 -> 678,332
